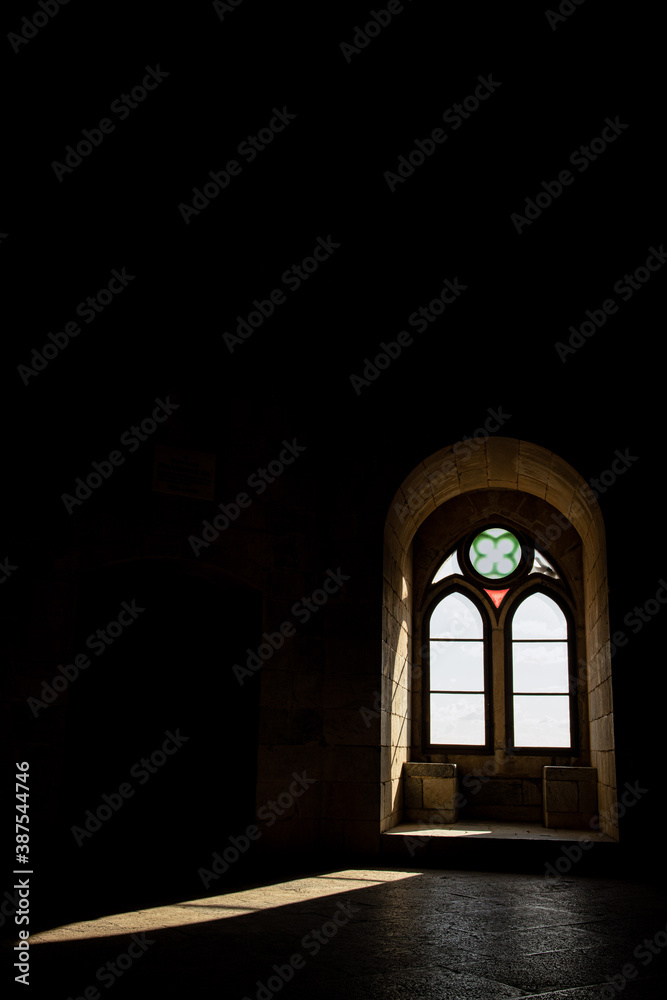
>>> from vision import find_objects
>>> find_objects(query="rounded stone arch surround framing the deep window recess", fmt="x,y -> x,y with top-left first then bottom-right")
380,437 -> 618,839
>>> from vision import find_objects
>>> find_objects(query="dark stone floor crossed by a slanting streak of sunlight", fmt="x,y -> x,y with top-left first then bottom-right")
14,866 -> 667,1000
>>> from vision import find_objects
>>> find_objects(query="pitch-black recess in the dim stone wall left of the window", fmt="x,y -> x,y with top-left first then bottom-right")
43,561 -> 261,928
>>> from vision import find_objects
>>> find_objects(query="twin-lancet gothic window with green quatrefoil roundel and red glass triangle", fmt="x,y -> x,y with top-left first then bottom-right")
422,524 -> 578,756
